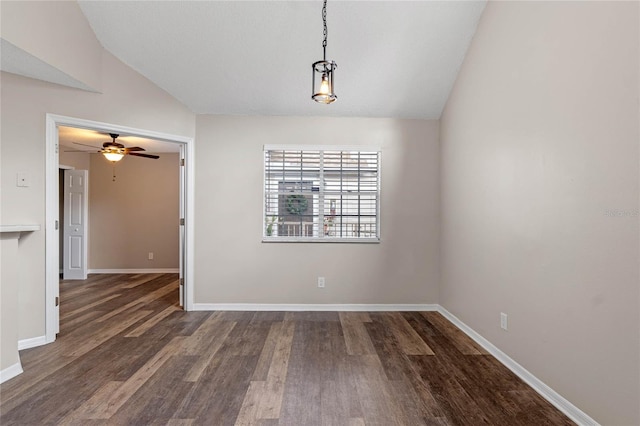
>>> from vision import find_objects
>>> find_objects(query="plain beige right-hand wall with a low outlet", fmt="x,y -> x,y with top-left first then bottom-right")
440,2 -> 640,425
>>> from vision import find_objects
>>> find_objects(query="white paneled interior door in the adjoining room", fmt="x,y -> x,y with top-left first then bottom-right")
62,170 -> 89,280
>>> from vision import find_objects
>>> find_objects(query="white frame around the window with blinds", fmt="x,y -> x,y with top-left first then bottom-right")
261,144 -> 382,244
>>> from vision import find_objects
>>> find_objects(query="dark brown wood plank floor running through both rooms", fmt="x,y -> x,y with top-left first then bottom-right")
0,274 -> 573,426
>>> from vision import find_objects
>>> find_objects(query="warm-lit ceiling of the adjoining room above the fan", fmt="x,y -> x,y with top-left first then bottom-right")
58,126 -> 180,154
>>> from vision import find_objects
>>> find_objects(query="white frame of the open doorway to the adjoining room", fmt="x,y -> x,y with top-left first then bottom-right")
45,114 -> 195,343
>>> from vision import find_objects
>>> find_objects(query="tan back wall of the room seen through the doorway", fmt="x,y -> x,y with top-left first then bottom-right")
89,153 -> 180,269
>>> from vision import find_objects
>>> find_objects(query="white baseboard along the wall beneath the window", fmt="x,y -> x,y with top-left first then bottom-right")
193,303 -> 438,312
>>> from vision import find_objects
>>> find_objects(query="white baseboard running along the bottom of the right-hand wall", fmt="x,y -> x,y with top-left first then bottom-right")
437,306 -> 599,426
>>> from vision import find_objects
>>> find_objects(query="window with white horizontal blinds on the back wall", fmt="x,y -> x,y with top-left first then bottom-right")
263,146 -> 380,242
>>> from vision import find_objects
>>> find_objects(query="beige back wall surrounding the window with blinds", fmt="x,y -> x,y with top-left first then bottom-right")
195,116 -> 439,303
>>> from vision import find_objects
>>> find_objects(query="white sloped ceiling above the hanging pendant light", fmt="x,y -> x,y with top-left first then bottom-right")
79,1 -> 485,118
